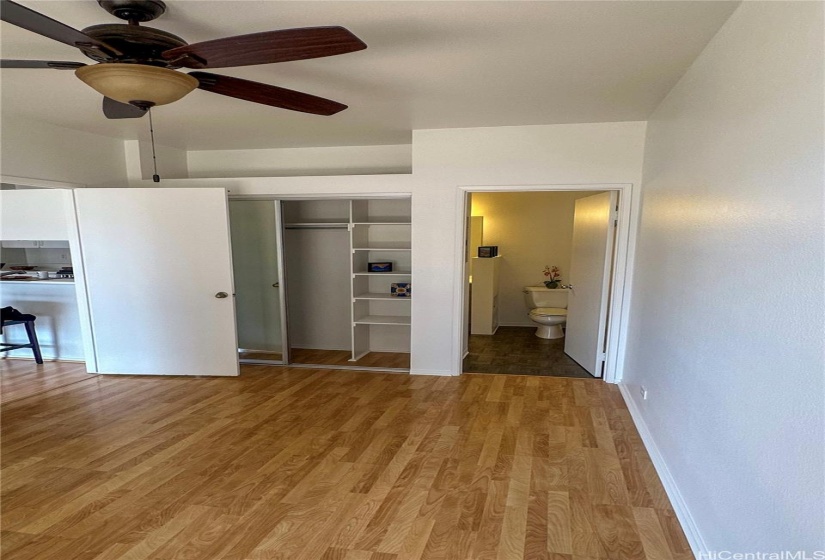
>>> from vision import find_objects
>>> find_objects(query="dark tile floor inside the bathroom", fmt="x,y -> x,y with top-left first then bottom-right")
464,327 -> 593,379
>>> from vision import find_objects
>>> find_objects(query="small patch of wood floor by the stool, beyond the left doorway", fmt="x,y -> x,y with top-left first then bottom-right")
0,358 -> 89,403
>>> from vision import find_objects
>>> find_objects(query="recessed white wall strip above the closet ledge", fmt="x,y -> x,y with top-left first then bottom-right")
183,144 -> 412,177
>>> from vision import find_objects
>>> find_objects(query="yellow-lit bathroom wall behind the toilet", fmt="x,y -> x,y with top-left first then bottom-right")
472,192 -> 597,327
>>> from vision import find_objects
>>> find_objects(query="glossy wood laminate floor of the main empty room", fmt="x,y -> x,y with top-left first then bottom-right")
0,364 -> 691,560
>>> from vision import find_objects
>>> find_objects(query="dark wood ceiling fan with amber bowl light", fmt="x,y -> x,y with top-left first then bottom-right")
0,0 -> 367,119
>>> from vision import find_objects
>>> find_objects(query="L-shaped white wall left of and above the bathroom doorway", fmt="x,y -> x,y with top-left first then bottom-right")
412,122 -> 645,374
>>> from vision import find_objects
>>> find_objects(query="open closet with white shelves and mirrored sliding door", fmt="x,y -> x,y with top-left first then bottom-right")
230,197 -> 412,371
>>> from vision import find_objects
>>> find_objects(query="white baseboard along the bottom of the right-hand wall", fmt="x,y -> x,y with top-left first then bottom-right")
618,382 -> 710,558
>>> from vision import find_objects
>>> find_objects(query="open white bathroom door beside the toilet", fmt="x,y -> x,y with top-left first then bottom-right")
564,191 -> 618,377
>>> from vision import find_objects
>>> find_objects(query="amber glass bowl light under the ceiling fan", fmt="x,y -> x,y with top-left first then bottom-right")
75,63 -> 198,105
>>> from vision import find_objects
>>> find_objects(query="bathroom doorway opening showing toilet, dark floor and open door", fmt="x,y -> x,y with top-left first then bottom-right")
462,186 -> 619,378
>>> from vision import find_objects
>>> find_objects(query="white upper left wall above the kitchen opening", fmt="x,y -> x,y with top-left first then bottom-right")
0,114 -> 127,187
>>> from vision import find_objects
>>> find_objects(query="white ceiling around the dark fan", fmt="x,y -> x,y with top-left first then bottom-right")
0,0 -> 737,150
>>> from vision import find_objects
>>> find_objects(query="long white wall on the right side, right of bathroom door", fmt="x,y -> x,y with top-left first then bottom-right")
624,2 -> 825,552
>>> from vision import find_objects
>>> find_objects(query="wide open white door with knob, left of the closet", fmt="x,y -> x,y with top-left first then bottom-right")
74,188 -> 238,375
